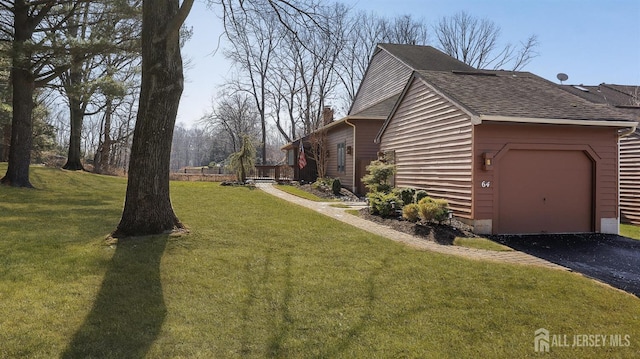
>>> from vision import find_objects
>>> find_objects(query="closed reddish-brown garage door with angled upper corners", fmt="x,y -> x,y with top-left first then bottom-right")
498,150 -> 593,234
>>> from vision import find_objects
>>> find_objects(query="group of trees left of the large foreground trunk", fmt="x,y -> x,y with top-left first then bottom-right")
0,0 -> 141,187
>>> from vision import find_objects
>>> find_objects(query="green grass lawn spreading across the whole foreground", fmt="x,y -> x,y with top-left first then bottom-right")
0,164 -> 640,358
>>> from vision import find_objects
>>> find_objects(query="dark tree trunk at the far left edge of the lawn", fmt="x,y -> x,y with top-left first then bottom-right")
0,1 -> 35,188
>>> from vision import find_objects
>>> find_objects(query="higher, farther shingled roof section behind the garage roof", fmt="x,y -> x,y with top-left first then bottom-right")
378,44 -> 475,71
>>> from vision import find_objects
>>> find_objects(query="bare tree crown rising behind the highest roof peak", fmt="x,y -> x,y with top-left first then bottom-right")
434,11 -> 538,71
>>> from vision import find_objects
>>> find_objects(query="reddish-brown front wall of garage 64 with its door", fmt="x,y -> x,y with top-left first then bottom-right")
473,121 -> 632,234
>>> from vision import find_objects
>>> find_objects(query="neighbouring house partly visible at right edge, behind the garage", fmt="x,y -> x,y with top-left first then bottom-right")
560,83 -> 640,225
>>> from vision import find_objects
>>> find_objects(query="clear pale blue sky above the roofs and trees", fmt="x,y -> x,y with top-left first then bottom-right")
177,0 -> 640,127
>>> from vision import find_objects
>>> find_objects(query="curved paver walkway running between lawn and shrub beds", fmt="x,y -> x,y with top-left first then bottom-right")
257,183 -> 569,270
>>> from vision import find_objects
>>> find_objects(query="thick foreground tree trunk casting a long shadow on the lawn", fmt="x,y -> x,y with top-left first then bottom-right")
113,0 -> 193,237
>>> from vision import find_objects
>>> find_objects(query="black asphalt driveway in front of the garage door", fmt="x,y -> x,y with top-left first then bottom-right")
491,234 -> 640,297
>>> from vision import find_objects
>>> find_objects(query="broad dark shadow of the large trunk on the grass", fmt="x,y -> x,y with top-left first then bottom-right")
62,235 -> 169,358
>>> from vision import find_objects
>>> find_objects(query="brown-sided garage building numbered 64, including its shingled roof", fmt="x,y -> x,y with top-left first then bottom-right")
376,71 -> 637,234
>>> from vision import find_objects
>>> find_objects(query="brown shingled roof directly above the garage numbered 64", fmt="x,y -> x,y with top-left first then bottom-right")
417,71 -> 635,121
